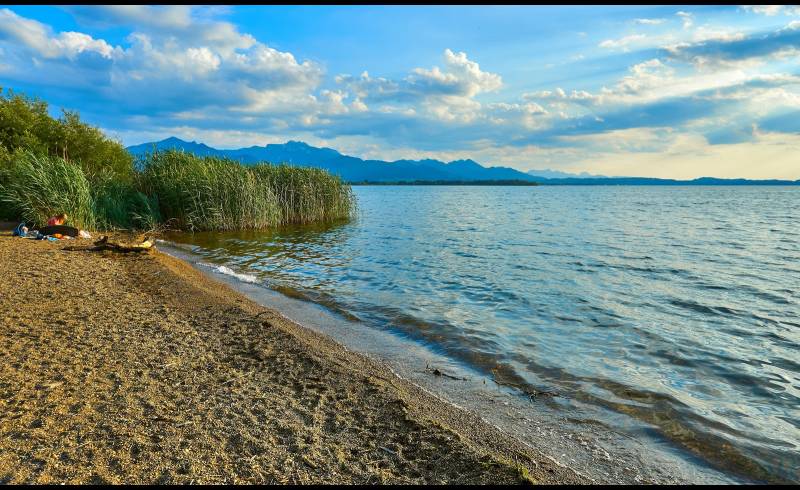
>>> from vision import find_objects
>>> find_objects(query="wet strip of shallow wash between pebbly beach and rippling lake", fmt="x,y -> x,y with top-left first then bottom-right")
158,240 -> 747,484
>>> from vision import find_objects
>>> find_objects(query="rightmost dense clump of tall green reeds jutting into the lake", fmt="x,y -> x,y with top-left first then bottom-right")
140,150 -> 355,230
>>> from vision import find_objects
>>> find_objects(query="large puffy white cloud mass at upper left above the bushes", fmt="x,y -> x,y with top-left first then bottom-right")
0,6 -> 325,117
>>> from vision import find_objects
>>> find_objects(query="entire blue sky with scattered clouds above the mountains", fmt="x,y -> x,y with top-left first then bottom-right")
0,5 -> 800,179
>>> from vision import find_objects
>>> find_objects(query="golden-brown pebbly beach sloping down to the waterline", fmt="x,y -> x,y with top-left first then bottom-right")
0,231 -> 589,484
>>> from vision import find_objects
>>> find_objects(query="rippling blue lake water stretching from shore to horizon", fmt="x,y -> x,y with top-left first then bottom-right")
164,186 -> 800,482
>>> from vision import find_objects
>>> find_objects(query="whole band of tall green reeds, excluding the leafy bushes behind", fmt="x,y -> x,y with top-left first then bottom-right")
0,150 -> 355,231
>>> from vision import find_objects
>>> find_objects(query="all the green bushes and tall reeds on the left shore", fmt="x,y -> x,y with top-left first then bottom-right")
0,89 -> 356,230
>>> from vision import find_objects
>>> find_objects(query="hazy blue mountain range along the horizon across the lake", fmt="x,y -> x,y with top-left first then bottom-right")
128,137 -> 800,185
